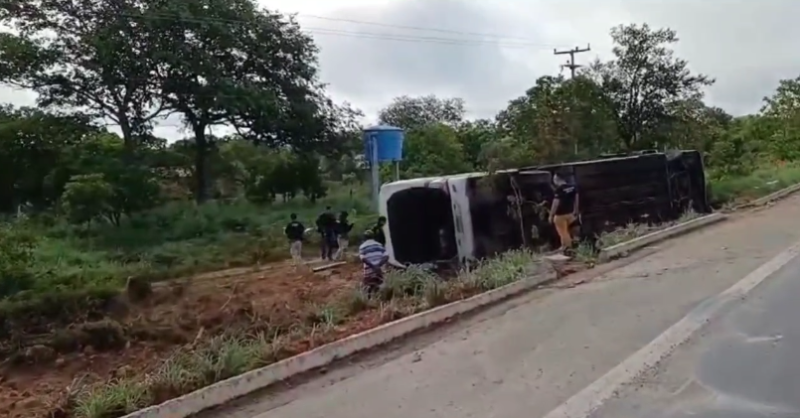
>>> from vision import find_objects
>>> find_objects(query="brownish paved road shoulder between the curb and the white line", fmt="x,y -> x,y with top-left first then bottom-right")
202,196 -> 800,418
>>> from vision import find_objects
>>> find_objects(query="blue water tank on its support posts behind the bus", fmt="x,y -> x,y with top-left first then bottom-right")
364,125 -> 405,210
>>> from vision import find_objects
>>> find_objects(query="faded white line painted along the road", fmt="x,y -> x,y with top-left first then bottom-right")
544,237 -> 800,418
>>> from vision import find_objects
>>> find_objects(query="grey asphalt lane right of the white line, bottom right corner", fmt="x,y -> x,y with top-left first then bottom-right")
592,243 -> 800,418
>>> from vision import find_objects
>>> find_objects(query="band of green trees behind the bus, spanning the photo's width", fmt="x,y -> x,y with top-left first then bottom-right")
0,13 -> 800,224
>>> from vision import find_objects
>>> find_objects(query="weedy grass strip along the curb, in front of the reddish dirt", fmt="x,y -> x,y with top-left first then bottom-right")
60,250 -> 543,418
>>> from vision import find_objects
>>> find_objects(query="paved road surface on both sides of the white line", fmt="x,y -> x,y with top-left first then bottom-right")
201,197 -> 800,418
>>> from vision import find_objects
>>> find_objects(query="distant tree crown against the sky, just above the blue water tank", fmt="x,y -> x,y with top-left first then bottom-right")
378,95 -> 466,131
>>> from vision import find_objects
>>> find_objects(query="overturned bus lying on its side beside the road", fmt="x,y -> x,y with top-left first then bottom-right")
379,151 -> 710,265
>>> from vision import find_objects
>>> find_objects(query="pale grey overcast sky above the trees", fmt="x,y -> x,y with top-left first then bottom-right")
0,0 -> 800,138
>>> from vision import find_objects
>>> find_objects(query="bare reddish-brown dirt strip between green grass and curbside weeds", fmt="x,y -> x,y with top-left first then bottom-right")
0,262 -> 368,418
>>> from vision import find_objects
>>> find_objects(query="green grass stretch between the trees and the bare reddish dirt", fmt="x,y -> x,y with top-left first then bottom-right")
0,186 -> 376,303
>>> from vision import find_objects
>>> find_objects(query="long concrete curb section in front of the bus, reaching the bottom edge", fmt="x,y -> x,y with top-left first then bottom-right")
123,274 -> 550,418
